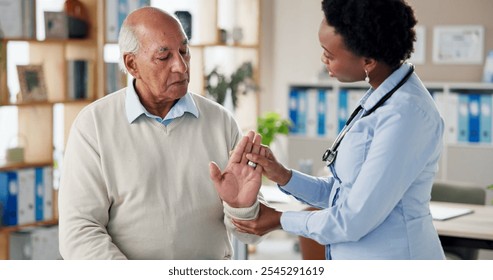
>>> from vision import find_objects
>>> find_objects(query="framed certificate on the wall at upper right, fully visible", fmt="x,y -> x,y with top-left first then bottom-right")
433,25 -> 484,64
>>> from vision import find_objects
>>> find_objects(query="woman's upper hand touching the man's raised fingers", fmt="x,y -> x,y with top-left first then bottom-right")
246,142 -> 292,186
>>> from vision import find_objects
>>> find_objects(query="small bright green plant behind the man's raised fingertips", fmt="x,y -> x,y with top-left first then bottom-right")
257,112 -> 291,146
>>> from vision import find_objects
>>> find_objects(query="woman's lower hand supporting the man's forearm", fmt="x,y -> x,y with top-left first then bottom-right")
233,203 -> 282,236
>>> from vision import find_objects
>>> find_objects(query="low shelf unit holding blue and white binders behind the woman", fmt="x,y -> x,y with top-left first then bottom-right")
288,81 -> 493,190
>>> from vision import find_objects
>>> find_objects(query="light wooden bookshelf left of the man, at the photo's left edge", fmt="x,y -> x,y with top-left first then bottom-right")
0,0 -> 103,259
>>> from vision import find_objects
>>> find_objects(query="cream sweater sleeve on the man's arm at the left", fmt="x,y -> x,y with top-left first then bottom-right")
59,111 -> 127,259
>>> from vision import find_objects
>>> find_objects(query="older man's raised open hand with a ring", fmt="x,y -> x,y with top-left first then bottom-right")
209,131 -> 265,208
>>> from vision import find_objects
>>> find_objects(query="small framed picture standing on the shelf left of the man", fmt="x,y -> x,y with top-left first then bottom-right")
17,65 -> 47,102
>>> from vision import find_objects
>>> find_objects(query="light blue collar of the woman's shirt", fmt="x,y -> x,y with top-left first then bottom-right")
361,62 -> 411,111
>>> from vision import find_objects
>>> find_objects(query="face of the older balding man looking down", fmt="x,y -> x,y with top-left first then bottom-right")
134,21 -> 190,102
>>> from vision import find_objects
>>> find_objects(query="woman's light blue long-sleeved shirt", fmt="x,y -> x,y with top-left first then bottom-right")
281,64 -> 444,259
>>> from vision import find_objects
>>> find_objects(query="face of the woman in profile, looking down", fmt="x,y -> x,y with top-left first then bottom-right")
318,18 -> 366,82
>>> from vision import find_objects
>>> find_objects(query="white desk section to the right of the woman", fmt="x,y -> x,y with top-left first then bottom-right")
431,201 -> 493,250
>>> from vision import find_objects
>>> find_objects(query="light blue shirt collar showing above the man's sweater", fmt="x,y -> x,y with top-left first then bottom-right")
125,82 -> 199,125
